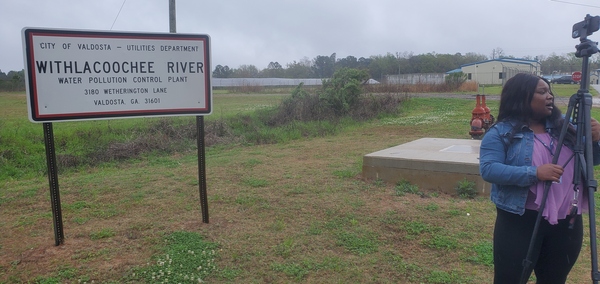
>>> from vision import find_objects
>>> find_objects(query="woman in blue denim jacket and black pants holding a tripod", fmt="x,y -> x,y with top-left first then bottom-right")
479,73 -> 600,284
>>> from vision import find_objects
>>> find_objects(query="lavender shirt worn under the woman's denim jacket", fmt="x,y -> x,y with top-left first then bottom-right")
525,133 -> 588,225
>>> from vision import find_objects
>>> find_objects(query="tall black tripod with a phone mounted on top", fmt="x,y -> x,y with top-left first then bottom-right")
521,15 -> 600,284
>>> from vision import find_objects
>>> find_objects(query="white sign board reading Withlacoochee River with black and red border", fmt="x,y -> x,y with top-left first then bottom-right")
22,28 -> 212,122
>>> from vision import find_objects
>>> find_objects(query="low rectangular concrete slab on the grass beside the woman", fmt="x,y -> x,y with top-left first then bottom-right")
363,138 -> 491,195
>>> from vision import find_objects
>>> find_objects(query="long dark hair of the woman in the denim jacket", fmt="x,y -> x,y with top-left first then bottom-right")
498,73 -> 574,142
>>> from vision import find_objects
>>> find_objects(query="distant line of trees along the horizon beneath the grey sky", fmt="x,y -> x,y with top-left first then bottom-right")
0,48 -> 600,91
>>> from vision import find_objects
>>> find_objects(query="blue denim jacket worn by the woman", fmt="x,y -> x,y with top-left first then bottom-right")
479,121 -> 600,215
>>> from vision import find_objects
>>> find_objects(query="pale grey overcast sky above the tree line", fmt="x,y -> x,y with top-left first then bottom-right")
0,0 -> 600,73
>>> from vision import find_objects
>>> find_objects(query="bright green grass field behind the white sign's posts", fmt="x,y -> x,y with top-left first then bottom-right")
0,93 -> 283,180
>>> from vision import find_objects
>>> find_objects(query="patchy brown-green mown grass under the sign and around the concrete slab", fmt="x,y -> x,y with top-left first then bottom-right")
0,86 -> 600,283
